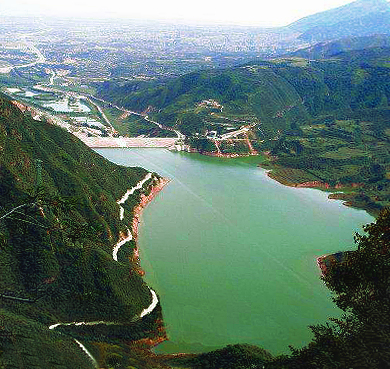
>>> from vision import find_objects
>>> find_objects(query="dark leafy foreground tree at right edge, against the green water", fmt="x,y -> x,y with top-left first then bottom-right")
323,209 -> 390,318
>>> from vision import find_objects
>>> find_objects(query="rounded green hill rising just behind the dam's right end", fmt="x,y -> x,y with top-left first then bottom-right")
96,63 -> 308,134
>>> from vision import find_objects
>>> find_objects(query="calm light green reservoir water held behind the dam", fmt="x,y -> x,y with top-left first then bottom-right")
97,149 -> 373,354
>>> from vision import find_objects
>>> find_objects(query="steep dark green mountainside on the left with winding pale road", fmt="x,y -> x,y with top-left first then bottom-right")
0,96 -> 165,368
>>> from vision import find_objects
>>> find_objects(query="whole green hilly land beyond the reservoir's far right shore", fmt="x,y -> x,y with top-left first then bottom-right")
101,46 -> 390,214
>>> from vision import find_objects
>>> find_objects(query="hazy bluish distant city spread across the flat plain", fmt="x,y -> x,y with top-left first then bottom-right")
0,18 -> 302,85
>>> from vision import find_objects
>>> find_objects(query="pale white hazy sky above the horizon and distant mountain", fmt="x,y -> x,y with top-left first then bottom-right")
0,0 -> 378,26
